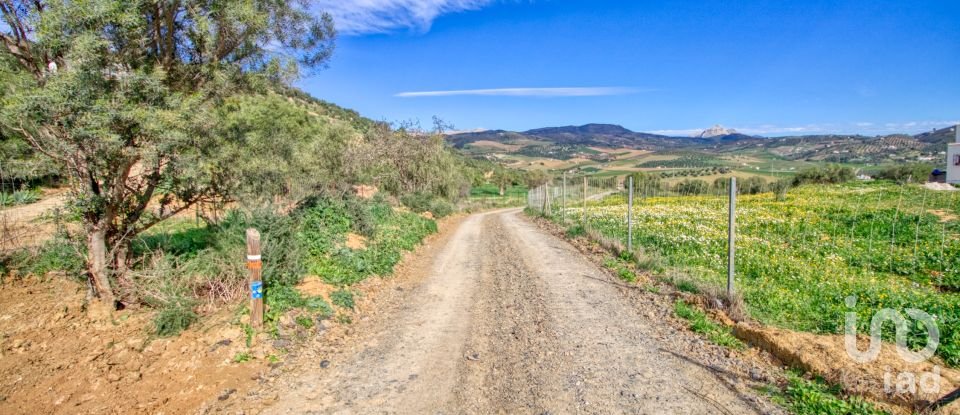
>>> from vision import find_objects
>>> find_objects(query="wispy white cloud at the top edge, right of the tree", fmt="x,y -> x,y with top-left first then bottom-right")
313,0 -> 492,36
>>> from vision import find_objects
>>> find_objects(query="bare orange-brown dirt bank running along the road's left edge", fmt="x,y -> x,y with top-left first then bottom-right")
0,213 -> 461,414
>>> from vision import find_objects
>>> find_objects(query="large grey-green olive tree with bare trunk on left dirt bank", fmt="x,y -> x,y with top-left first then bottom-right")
0,0 -> 335,304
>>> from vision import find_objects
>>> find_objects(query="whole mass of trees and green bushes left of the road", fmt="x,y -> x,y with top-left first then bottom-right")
0,0 -> 526,342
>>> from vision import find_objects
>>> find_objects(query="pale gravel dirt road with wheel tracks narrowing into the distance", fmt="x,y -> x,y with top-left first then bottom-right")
229,210 -> 775,414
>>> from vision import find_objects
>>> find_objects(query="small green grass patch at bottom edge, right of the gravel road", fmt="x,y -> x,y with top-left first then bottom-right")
772,372 -> 886,415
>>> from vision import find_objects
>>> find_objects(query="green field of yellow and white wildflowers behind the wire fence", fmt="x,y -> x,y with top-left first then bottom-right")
554,182 -> 960,366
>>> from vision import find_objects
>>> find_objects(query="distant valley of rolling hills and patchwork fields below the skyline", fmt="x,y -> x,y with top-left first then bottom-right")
446,124 -> 954,181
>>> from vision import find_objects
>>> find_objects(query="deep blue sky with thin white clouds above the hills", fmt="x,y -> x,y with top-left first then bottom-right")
299,0 -> 960,136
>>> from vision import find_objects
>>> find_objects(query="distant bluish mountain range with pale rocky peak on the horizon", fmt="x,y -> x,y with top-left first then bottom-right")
447,124 -> 955,162
